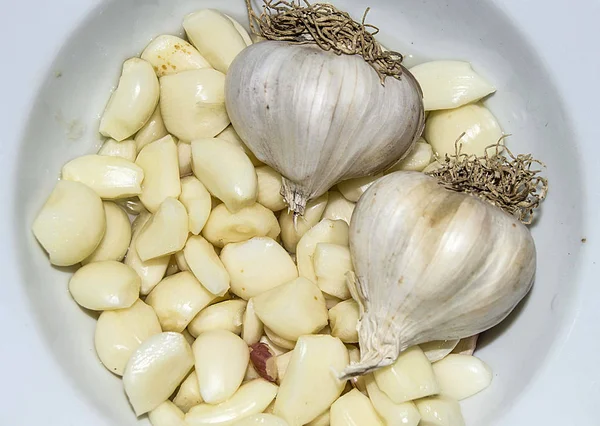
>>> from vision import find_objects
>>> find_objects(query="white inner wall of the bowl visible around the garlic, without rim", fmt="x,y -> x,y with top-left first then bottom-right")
12,0 -> 583,425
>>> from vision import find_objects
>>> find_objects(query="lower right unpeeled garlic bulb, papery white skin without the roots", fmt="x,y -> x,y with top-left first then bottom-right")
345,172 -> 536,376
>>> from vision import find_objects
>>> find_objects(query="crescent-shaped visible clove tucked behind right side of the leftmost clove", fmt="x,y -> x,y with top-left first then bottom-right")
81,201 -> 131,265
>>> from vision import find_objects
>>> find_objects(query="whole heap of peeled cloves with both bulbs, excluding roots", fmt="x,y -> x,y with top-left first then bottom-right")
33,1 -> 548,426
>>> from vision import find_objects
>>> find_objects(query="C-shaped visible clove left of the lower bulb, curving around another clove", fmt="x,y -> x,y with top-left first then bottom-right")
296,219 -> 348,282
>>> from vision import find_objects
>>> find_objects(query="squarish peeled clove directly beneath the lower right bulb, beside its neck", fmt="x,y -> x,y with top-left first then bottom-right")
373,346 -> 440,404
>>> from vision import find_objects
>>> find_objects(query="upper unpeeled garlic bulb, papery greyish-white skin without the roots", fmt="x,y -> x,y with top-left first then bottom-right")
225,41 -> 424,214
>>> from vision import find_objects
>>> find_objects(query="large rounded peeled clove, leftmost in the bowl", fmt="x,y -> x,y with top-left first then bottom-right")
32,180 -> 106,266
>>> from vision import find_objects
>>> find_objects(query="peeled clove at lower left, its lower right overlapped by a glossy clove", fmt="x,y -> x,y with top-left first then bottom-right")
94,299 -> 162,376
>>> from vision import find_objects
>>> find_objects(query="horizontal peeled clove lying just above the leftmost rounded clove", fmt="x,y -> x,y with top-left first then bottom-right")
61,155 -> 144,199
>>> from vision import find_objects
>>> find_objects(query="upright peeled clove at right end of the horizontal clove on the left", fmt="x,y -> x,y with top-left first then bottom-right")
135,135 -> 181,213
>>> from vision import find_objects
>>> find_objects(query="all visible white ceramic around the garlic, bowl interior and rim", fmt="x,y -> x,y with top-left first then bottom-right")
0,0 -> 600,426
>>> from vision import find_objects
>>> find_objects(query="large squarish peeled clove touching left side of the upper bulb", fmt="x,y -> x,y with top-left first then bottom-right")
160,68 -> 229,142
